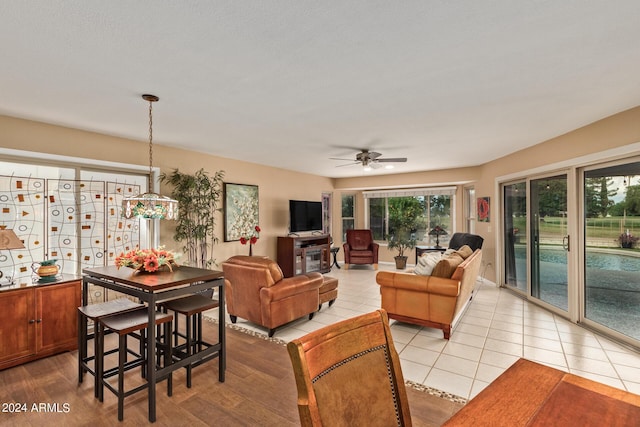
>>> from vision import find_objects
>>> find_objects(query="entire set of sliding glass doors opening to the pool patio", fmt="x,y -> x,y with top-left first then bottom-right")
501,158 -> 640,345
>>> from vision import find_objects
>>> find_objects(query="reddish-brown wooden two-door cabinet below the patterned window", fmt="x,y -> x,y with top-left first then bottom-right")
0,279 -> 81,369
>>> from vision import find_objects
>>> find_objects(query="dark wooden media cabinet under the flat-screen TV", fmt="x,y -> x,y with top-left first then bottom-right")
278,234 -> 331,277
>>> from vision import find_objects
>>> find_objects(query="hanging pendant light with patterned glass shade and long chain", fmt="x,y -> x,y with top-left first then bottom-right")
122,95 -> 178,219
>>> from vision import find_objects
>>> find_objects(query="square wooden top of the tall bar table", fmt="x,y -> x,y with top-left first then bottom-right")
82,265 -> 224,292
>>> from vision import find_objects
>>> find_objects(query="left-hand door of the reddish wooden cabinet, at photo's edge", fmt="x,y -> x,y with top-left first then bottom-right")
0,289 -> 36,364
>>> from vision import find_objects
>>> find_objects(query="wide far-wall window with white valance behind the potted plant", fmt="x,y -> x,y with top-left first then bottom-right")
364,187 -> 455,245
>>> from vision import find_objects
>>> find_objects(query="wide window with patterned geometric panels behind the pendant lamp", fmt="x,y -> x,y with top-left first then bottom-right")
0,161 -> 147,297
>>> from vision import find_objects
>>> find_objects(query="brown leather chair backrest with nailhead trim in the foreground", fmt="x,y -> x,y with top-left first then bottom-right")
287,310 -> 411,426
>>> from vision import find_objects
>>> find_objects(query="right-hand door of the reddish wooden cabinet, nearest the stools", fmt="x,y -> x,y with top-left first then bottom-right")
36,281 -> 81,352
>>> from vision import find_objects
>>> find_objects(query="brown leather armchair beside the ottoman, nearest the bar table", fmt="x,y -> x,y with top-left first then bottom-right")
222,255 -> 323,337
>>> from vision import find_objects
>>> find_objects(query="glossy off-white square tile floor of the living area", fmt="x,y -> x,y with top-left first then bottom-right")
205,264 -> 640,399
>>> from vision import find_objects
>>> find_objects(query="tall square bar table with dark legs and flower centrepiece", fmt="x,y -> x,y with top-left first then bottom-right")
82,266 -> 226,422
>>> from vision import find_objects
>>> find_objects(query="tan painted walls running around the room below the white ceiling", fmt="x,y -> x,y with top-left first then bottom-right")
5,107 -> 640,280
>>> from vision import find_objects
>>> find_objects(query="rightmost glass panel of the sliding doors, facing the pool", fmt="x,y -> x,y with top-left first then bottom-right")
583,162 -> 640,340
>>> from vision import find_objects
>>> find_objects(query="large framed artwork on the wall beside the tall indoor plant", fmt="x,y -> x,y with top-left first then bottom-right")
224,182 -> 260,242
